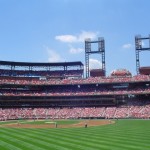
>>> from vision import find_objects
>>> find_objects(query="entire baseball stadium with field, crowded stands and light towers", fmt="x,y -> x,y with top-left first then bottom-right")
0,36 -> 150,150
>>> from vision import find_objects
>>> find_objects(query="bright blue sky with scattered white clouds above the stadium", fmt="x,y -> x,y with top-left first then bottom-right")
0,0 -> 150,75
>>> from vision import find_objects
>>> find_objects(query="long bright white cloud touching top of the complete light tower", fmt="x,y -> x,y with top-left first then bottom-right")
55,31 -> 98,43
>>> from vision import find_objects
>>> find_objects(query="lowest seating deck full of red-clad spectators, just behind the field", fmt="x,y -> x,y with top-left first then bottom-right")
0,104 -> 150,121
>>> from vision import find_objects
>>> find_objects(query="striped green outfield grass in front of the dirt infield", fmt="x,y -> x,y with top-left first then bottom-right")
0,120 -> 150,150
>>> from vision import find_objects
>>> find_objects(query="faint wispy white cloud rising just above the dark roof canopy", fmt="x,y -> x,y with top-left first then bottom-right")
47,48 -> 64,62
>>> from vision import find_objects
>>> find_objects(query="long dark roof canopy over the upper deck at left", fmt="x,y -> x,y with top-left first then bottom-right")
0,61 -> 83,67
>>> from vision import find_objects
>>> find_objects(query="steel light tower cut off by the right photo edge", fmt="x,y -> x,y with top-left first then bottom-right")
135,35 -> 150,74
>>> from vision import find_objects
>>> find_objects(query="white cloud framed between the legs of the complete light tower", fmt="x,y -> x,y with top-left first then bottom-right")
89,59 -> 102,69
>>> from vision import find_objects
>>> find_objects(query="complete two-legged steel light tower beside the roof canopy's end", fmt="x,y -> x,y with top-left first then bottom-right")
85,37 -> 106,78
